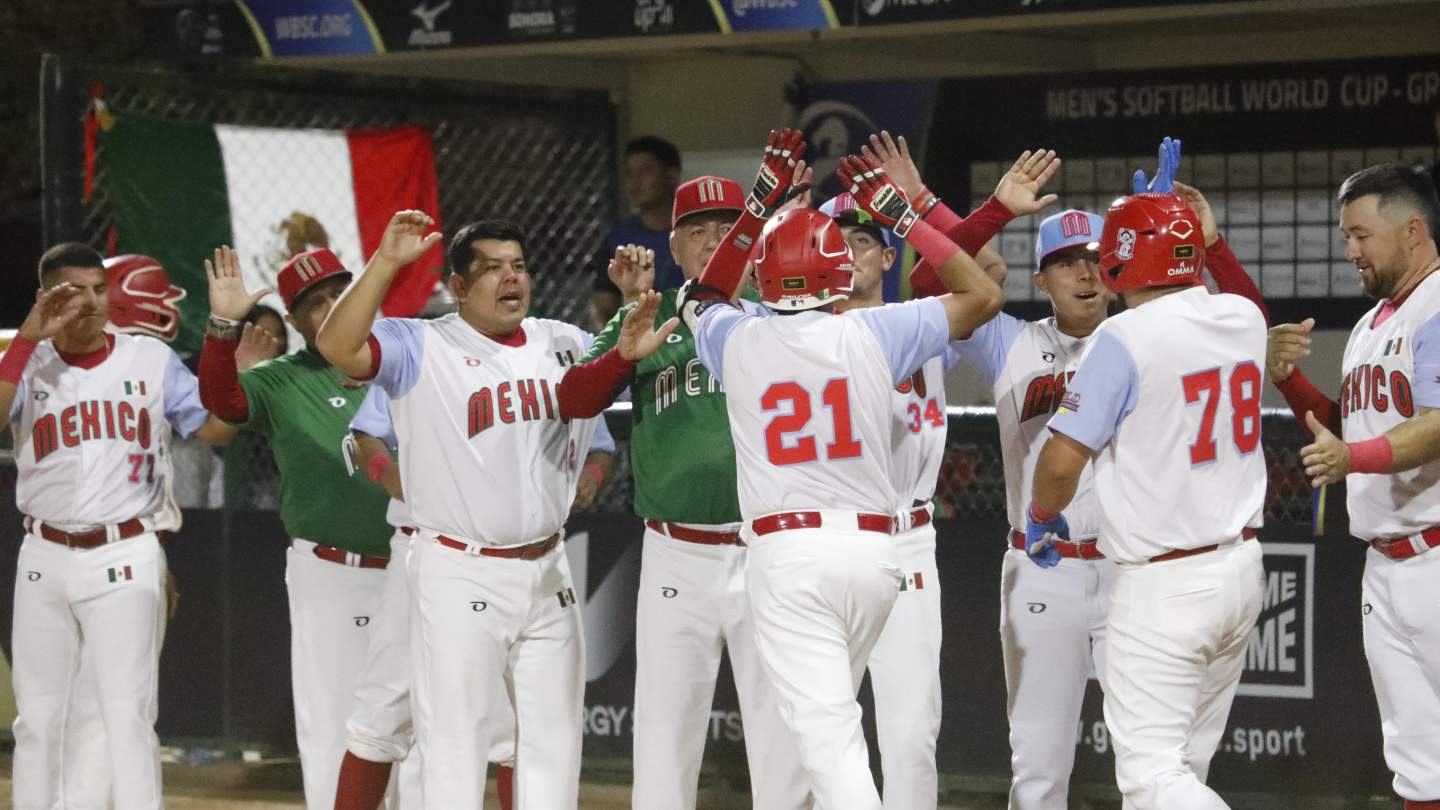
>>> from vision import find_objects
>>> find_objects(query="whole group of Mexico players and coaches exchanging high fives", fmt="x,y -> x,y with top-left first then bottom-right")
0,121 -> 1440,810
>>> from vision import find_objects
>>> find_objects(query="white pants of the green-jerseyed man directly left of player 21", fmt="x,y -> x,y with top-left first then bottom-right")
631,525 -> 809,810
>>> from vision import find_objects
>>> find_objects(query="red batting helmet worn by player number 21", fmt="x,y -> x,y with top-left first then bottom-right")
755,208 -> 855,311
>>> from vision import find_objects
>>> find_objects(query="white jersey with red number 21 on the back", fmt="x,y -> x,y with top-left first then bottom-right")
696,298 -> 950,520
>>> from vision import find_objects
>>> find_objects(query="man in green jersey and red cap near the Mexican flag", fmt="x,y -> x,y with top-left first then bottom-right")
200,240 -> 390,810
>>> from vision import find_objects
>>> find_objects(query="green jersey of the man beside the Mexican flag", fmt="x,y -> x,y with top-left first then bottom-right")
239,347 -> 390,556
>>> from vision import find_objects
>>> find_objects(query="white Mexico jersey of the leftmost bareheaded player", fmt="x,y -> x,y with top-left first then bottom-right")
10,334 -> 210,530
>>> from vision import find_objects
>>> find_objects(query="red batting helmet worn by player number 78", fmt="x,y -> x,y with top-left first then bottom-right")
1100,193 -> 1205,294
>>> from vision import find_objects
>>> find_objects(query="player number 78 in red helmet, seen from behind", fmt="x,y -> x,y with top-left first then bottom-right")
1025,179 -> 1266,810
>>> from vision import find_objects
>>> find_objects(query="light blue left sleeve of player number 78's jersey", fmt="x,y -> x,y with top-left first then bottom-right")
1050,331 -> 1140,450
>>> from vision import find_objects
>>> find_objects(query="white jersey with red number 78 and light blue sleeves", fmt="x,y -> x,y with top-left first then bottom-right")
1050,287 -> 1267,562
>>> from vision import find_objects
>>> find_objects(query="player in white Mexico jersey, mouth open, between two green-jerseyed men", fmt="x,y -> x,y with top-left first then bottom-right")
320,210 -> 648,809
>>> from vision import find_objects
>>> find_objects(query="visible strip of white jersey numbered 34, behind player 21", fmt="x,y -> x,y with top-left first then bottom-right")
890,352 -> 953,506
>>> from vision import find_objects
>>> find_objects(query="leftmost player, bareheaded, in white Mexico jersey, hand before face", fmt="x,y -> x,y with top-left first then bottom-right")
0,242 -> 232,810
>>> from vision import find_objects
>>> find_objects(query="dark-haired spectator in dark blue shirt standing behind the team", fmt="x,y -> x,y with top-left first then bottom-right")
590,135 -> 685,333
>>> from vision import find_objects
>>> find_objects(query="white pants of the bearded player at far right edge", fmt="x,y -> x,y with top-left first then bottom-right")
1361,539 -> 1440,801
